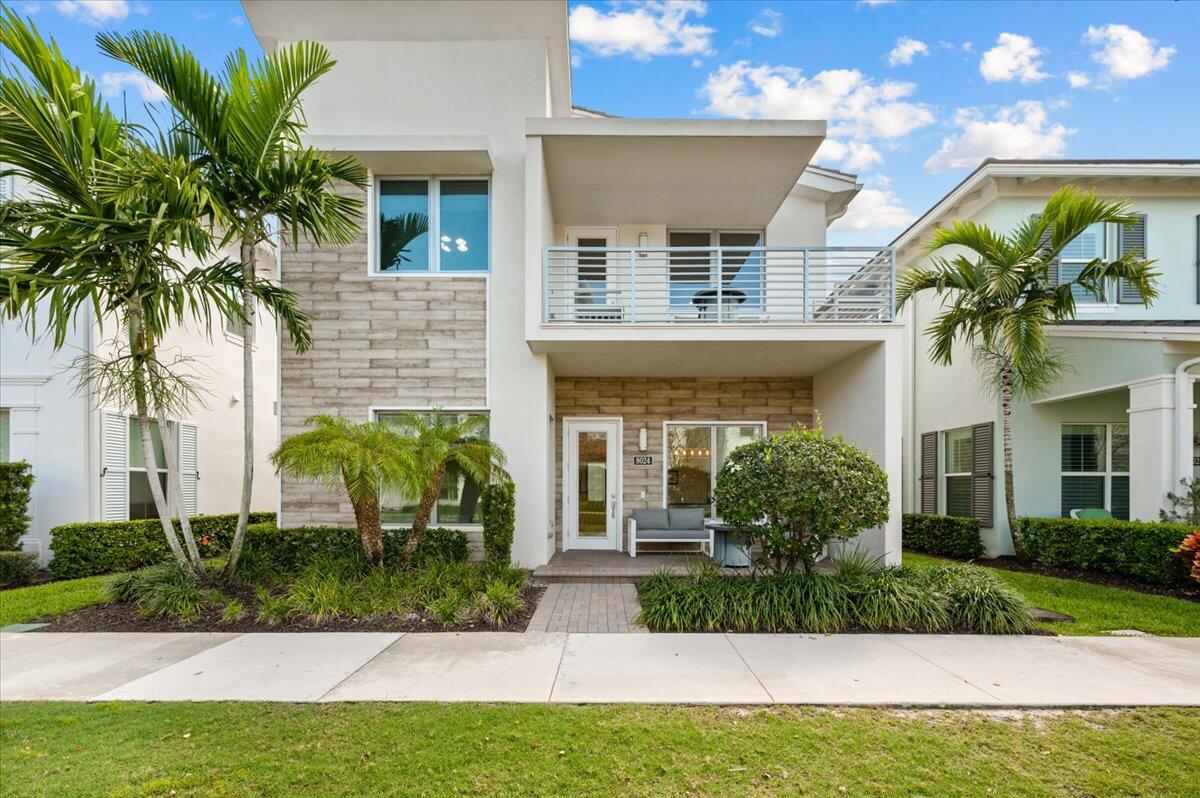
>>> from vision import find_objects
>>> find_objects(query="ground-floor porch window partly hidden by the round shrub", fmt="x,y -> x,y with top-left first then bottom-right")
662,421 -> 767,517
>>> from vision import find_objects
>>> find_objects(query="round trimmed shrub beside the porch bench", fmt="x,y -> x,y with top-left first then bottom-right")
716,427 -> 888,572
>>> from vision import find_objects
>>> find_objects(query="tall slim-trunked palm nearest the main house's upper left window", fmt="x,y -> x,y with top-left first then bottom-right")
96,31 -> 366,574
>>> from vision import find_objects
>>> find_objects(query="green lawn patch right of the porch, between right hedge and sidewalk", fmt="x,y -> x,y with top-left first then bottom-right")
904,552 -> 1200,637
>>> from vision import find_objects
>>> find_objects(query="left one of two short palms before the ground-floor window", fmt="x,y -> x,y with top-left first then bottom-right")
271,415 -> 409,565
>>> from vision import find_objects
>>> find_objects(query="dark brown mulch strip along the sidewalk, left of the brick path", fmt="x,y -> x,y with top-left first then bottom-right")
34,587 -> 546,632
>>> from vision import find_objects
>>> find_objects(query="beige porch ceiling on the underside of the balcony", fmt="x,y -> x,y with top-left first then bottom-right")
539,340 -> 878,378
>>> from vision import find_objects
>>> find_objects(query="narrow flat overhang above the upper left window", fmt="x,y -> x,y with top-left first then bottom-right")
304,136 -> 492,175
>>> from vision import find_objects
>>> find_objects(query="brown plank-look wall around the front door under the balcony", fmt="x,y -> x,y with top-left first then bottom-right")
554,377 -> 814,550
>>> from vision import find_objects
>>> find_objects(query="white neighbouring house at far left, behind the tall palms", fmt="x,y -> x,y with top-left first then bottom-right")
0,174 -> 278,564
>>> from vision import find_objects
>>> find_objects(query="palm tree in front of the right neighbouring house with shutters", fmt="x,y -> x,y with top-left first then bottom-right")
896,186 -> 1158,553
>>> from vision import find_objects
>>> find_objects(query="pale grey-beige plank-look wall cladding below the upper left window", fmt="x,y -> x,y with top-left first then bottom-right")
280,183 -> 487,538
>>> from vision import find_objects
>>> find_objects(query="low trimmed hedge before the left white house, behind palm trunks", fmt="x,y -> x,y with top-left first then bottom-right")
49,512 -> 275,580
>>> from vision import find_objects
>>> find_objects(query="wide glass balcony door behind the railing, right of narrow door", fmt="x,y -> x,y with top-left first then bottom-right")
667,230 -> 763,313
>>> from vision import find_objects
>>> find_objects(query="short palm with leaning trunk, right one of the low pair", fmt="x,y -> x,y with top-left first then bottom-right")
392,409 -> 510,568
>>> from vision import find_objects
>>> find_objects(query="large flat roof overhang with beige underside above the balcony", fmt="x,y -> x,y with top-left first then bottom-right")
526,118 -> 826,228
